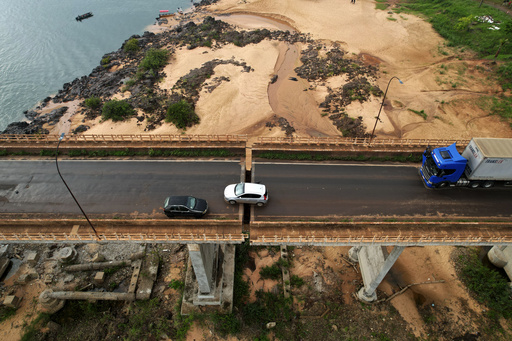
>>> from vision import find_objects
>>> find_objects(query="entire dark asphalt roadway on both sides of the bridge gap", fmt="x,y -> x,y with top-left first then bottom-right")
0,160 -> 512,220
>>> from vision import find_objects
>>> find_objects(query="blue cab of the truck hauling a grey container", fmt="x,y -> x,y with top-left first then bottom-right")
420,143 -> 468,188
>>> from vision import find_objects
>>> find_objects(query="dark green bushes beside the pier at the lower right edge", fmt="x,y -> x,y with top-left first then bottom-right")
460,249 -> 512,321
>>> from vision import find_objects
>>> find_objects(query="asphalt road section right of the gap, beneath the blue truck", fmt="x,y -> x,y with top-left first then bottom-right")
253,163 -> 512,218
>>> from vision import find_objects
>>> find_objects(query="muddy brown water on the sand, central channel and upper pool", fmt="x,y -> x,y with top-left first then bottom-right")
216,14 -> 339,137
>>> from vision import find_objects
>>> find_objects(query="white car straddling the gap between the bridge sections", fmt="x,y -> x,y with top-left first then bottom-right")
224,182 -> 268,206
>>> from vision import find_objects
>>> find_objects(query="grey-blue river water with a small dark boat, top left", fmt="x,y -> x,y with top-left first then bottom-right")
0,0 -> 192,132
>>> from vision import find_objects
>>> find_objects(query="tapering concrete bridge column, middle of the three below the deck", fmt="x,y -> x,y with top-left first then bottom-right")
357,246 -> 405,302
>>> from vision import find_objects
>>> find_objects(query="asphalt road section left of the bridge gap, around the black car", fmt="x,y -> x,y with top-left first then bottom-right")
0,160 -> 241,218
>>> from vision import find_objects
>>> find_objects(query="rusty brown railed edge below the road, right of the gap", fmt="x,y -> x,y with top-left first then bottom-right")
251,221 -> 512,246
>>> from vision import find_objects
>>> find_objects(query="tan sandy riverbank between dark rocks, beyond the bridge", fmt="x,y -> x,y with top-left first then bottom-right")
43,0 -> 512,139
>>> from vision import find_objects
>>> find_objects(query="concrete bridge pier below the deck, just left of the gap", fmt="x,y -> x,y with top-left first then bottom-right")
181,244 -> 235,315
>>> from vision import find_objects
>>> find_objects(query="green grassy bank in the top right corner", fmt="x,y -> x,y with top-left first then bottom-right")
399,0 -> 512,59
